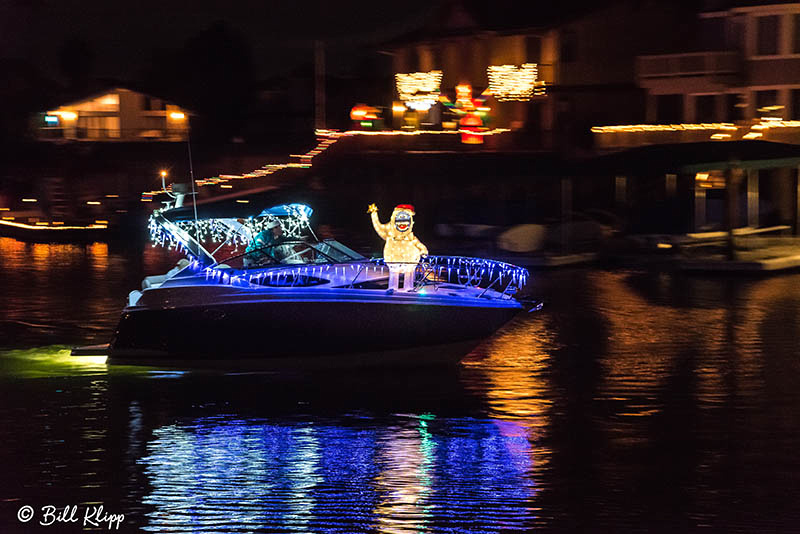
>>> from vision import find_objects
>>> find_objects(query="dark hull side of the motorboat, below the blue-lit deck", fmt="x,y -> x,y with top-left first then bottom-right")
109,290 -> 520,367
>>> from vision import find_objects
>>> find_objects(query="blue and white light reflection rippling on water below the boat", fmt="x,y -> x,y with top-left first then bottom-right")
139,414 -> 536,533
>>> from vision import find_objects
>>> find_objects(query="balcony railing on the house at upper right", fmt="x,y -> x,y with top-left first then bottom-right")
636,51 -> 741,78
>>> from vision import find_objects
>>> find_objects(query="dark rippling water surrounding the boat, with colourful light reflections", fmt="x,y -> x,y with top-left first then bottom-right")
0,239 -> 800,533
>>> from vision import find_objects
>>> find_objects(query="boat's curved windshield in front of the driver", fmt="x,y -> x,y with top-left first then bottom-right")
219,239 -> 367,268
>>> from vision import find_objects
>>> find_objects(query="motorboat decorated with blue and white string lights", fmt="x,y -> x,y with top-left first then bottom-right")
73,198 -> 528,367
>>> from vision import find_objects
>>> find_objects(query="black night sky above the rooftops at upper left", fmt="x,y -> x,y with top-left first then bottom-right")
0,0 -> 436,79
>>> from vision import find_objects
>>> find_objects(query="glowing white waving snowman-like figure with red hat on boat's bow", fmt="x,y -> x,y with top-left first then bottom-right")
367,204 -> 428,291
